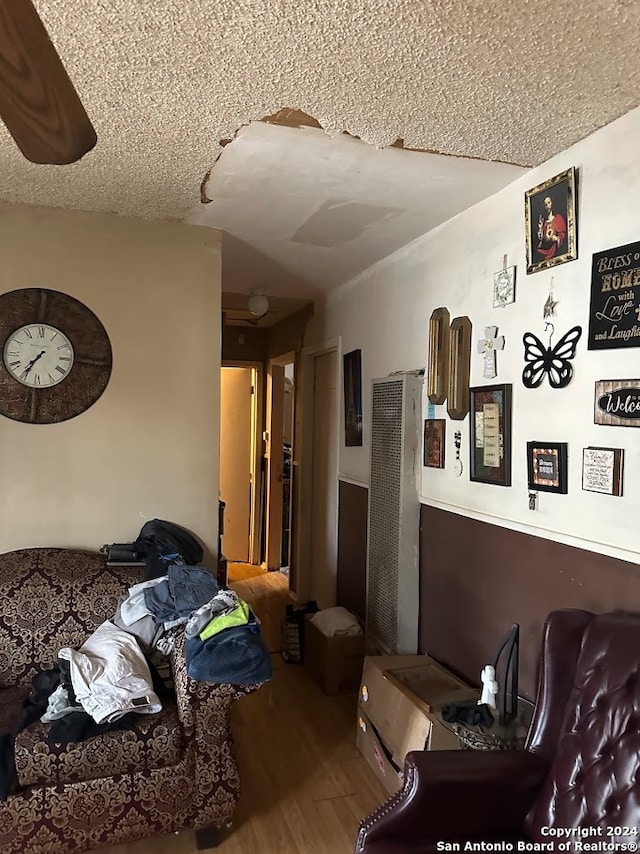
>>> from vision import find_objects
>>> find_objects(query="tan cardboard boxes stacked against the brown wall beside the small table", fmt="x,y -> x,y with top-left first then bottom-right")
357,655 -> 477,791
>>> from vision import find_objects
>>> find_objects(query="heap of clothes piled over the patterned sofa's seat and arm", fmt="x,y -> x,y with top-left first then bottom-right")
0,565 -> 271,800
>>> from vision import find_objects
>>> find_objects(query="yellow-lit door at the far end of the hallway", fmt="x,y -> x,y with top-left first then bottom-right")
220,367 -> 254,562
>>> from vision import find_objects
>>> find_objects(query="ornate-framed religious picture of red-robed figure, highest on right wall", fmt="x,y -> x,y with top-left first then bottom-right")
524,166 -> 578,273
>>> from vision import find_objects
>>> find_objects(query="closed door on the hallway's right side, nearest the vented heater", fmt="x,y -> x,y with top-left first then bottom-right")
310,350 -> 338,608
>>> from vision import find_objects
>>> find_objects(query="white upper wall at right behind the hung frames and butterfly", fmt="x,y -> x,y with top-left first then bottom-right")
305,103 -> 640,563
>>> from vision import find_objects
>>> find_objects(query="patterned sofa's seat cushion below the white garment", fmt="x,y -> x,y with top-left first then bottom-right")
15,702 -> 181,786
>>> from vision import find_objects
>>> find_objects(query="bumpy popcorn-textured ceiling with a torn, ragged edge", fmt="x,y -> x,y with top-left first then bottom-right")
0,0 -> 640,298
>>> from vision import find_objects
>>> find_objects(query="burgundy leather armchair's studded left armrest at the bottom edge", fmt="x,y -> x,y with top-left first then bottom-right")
355,750 -> 548,854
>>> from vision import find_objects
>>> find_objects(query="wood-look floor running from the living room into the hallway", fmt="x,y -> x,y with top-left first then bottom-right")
92,564 -> 387,854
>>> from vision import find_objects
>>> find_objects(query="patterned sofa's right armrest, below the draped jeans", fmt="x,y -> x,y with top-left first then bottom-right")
171,633 -> 261,829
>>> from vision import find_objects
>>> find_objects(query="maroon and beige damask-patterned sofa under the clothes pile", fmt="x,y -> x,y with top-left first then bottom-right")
0,549 -> 257,854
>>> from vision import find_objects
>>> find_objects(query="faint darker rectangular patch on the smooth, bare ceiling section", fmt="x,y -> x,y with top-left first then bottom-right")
291,199 -> 405,246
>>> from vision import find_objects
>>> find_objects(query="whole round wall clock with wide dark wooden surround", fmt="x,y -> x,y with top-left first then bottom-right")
0,288 -> 112,424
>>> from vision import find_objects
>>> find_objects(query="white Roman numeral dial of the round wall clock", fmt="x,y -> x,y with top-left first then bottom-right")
4,323 -> 73,388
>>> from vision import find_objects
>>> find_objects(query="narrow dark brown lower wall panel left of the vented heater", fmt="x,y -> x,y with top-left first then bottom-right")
338,480 -> 369,620
